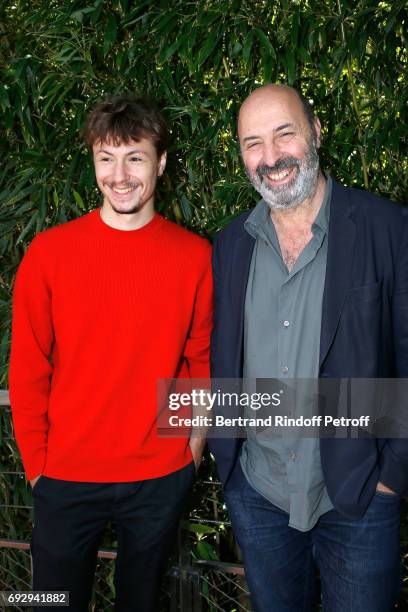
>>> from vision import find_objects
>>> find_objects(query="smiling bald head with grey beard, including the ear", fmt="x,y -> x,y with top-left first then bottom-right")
238,85 -> 320,209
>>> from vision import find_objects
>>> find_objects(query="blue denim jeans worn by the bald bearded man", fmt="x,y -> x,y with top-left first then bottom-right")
224,462 -> 400,612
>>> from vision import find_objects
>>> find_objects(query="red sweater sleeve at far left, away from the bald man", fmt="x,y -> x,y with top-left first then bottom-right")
9,237 -> 53,480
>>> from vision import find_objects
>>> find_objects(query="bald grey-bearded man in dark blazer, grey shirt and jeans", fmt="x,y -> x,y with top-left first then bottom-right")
211,85 -> 408,612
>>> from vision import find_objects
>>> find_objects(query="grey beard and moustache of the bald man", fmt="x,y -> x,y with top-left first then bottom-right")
249,142 -> 319,210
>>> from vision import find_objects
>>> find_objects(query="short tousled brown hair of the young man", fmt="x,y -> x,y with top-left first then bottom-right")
83,96 -> 169,156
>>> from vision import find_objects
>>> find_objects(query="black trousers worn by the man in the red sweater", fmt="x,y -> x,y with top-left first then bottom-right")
31,463 -> 195,612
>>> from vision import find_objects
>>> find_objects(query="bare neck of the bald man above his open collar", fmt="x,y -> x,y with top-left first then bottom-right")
270,172 -> 326,231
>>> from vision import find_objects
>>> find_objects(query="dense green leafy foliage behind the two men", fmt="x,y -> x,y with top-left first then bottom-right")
0,0 -> 408,608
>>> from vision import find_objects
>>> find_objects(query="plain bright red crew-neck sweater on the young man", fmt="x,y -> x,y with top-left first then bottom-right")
10,210 -> 212,482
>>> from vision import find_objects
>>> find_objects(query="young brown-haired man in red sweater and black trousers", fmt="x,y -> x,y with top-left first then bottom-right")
10,96 -> 212,612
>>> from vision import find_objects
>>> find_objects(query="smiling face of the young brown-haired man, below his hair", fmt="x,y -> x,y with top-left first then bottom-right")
92,138 -> 166,219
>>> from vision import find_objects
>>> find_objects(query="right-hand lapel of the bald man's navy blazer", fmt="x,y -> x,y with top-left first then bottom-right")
320,181 -> 356,368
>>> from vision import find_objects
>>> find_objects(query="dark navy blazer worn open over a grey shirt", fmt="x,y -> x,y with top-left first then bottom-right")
209,182 -> 408,518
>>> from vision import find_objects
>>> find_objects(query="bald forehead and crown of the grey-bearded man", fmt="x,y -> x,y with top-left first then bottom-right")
238,90 -> 307,140
